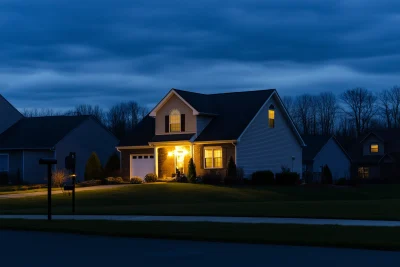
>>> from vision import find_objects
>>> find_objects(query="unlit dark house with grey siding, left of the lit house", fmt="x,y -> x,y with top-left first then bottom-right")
0,95 -> 119,183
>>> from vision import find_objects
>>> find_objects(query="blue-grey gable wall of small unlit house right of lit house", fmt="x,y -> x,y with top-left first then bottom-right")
313,138 -> 351,180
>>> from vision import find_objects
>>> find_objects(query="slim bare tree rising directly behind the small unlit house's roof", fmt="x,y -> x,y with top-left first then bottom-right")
316,92 -> 338,135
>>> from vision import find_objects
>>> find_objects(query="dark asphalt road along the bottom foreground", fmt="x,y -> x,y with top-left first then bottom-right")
0,231 -> 400,267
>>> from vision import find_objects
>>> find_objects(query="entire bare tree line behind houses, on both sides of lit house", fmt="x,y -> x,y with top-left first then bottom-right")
23,86 -> 400,139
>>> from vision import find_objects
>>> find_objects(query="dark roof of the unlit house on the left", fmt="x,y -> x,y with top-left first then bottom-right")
0,116 -> 91,150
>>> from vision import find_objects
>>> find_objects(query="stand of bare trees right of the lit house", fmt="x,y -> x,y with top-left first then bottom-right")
283,86 -> 400,137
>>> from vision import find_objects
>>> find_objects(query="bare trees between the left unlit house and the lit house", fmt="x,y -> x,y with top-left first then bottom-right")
22,101 -> 149,139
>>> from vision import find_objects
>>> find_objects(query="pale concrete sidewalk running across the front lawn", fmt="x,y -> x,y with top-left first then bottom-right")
0,215 -> 400,227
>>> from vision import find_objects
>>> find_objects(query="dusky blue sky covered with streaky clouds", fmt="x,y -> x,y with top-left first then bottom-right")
0,0 -> 400,109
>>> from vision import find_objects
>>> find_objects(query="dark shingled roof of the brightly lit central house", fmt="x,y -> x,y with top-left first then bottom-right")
120,89 -> 303,146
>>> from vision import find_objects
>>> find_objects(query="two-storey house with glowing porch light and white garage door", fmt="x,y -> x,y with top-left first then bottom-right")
118,89 -> 305,179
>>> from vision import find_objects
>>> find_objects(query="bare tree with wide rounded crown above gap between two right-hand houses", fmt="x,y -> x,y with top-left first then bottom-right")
340,88 -> 377,136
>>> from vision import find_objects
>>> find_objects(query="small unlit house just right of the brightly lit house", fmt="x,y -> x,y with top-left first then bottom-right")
302,135 -> 351,182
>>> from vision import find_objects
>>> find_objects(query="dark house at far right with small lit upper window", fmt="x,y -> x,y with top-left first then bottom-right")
341,129 -> 400,180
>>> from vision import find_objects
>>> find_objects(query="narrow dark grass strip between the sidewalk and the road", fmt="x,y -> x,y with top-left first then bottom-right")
0,220 -> 400,250
